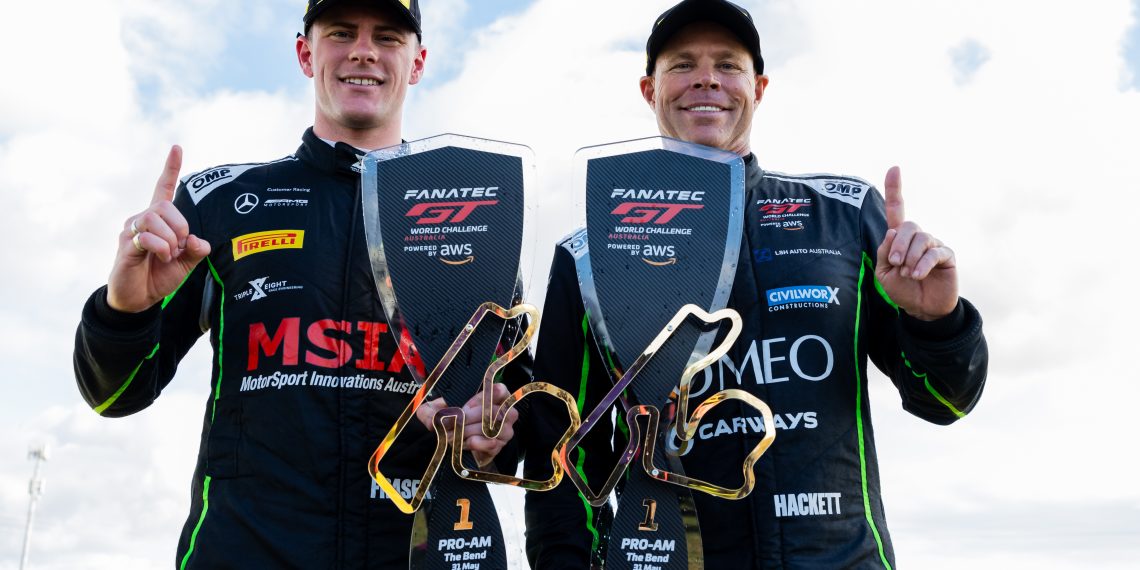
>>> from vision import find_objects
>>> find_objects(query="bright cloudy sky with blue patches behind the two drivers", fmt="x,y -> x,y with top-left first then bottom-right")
0,0 -> 1140,570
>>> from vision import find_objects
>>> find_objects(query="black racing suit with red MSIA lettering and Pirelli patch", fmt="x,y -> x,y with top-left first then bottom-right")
74,129 -> 529,570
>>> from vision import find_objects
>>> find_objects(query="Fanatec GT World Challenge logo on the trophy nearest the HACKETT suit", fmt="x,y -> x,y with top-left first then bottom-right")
606,188 -> 705,267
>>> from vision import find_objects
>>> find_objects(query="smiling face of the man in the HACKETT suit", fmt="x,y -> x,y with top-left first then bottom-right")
641,22 -> 768,156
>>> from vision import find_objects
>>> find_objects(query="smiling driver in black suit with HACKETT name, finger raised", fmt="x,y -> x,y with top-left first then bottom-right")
526,0 -> 987,570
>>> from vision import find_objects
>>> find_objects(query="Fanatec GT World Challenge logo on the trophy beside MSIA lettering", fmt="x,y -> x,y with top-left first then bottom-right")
404,186 -> 499,266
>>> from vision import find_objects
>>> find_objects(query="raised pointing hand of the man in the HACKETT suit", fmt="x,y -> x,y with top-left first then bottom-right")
874,166 -> 958,320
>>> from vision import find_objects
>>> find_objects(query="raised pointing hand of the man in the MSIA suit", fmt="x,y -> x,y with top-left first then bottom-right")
107,145 -> 210,312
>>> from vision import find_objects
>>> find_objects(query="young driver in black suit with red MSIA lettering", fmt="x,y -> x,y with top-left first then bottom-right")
75,0 -> 528,569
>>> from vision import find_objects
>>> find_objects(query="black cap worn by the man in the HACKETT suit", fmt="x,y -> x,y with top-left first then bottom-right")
645,0 -> 764,75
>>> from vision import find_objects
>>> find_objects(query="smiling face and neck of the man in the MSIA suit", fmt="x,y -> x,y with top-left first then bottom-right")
296,3 -> 428,149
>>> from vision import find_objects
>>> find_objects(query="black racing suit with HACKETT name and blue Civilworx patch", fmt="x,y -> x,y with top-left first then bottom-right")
524,156 -> 987,570
